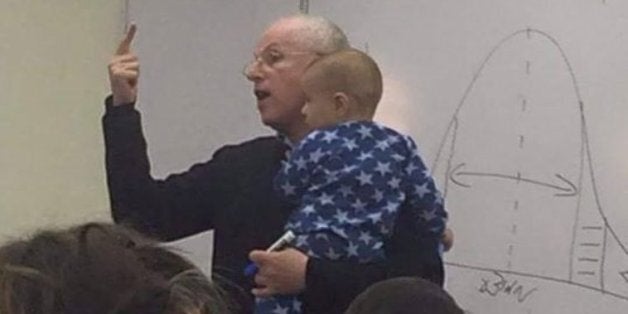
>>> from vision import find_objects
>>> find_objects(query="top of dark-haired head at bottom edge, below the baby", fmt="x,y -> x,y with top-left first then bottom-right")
345,277 -> 463,314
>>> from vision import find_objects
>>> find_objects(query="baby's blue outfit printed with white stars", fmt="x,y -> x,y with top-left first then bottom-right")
255,121 -> 447,314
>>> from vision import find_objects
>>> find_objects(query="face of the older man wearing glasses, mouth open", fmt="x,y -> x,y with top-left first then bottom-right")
246,21 -> 317,138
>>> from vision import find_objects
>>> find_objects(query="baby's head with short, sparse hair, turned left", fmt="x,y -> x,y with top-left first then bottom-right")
301,49 -> 382,128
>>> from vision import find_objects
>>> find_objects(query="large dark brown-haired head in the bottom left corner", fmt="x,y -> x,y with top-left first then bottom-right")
0,224 -> 230,314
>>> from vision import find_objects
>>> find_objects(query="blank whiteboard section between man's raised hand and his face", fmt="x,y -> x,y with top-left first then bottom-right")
128,0 -> 298,177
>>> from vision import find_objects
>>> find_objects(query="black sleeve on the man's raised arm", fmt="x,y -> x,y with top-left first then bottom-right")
103,96 -> 229,240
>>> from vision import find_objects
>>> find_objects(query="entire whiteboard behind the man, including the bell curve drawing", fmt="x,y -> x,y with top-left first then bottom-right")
130,0 -> 628,314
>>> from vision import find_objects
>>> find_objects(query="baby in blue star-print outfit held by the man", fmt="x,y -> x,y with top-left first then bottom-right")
255,49 -> 447,314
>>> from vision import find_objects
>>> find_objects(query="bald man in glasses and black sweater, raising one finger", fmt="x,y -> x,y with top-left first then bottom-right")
103,15 -> 443,314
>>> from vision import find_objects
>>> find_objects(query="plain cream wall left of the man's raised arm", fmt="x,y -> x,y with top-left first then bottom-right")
0,0 -> 124,241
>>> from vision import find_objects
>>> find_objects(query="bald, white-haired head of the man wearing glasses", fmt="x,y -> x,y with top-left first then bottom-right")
245,15 -> 349,139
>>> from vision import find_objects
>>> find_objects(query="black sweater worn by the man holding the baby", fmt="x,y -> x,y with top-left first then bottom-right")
103,97 -> 443,314
